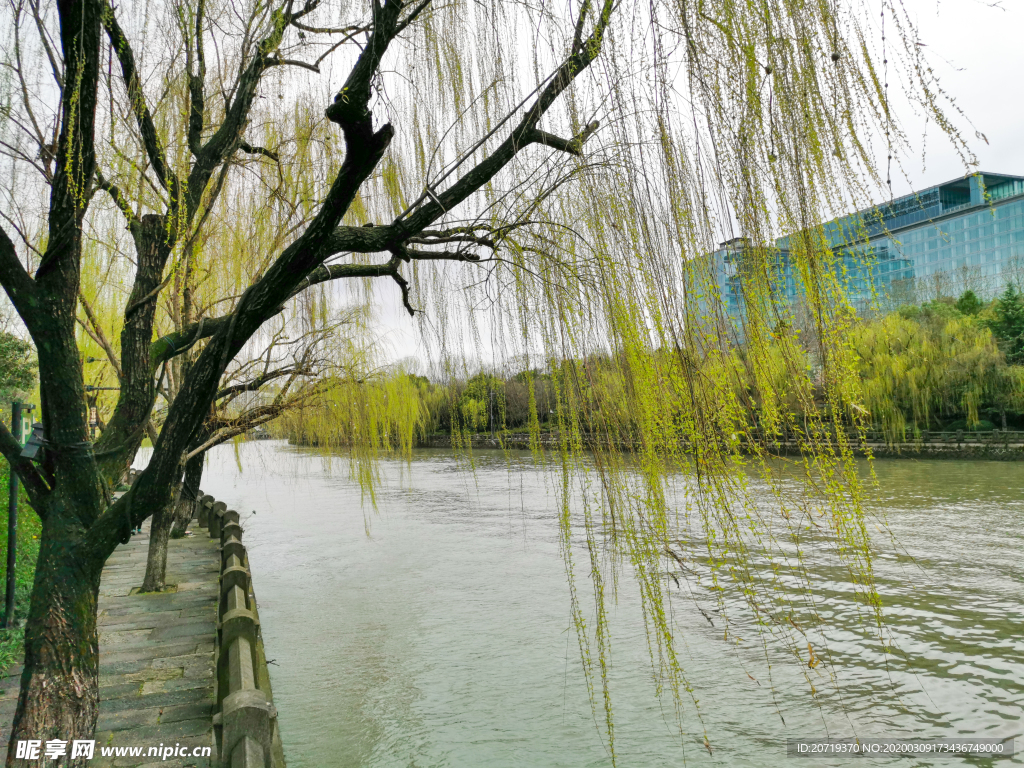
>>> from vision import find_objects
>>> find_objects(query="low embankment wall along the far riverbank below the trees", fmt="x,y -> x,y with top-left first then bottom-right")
416,429 -> 1024,461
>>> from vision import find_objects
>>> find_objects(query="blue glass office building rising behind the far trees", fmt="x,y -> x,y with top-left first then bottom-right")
713,173 -> 1024,317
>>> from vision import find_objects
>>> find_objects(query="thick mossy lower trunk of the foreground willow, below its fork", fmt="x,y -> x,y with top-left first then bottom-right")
7,534 -> 102,768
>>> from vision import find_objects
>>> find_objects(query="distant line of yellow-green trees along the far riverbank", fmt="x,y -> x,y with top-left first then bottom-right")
278,285 -> 1024,450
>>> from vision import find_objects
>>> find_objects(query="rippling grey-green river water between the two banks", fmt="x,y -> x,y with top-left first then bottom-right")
190,442 -> 1024,768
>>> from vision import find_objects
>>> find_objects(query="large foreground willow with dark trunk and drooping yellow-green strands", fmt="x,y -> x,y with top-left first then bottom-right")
0,0 -> 955,755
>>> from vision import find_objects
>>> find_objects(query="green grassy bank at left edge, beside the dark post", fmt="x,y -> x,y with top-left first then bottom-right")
0,462 -> 42,674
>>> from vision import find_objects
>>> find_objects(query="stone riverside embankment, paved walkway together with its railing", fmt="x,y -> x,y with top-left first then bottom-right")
0,479 -> 285,768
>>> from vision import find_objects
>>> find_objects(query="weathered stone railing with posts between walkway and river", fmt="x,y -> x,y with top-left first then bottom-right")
196,492 -> 285,768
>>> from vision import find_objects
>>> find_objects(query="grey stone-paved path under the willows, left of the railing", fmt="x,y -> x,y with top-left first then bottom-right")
0,520 -> 219,768
